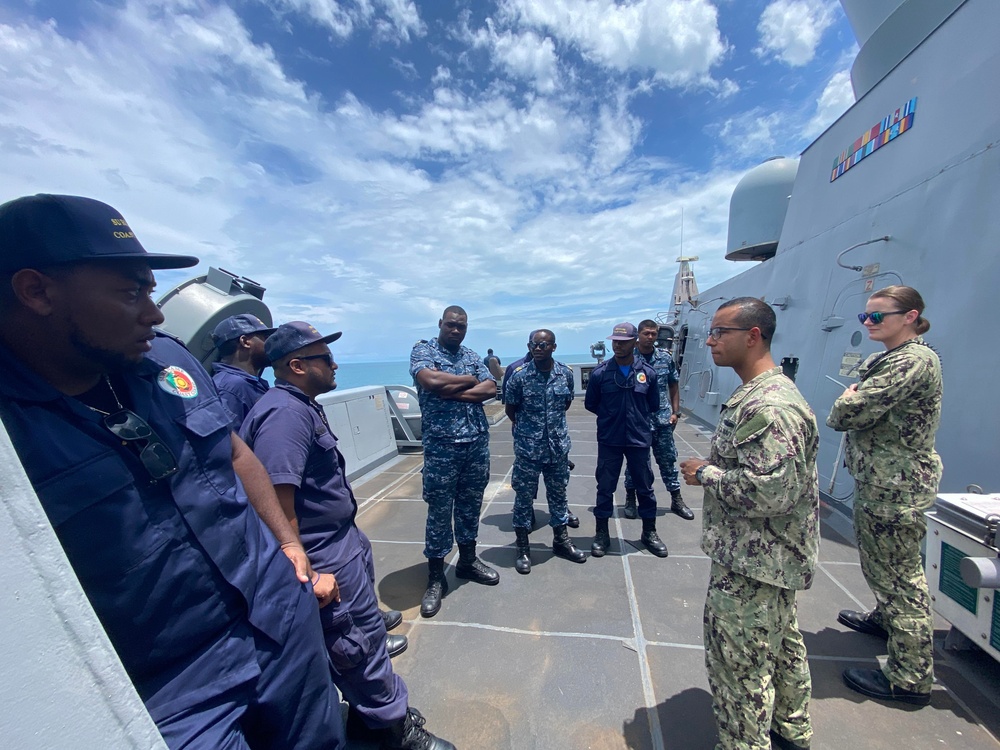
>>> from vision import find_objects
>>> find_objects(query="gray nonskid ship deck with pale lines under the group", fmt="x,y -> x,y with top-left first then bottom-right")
354,403 -> 1000,750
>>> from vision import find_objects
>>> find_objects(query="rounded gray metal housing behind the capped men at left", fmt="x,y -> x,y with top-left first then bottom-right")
156,268 -> 272,366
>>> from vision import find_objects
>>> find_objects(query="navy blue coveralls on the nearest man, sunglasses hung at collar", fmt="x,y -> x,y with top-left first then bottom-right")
0,337 -> 343,750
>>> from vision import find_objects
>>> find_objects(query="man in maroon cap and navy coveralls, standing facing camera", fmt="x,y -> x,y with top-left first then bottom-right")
584,323 -> 667,557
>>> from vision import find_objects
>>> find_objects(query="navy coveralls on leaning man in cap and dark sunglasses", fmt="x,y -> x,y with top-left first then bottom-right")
242,378 -> 409,729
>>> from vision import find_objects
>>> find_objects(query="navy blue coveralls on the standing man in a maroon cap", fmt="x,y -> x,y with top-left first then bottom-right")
583,357 -> 660,518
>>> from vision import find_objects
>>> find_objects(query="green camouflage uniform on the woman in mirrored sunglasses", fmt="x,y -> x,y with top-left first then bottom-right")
826,336 -> 942,692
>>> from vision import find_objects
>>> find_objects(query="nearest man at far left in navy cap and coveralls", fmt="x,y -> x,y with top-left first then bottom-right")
0,195 -> 343,750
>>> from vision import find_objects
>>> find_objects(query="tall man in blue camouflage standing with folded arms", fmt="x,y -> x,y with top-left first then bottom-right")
410,305 -> 500,617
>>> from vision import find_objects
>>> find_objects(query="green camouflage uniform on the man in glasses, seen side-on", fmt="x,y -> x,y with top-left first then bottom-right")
701,367 -> 819,750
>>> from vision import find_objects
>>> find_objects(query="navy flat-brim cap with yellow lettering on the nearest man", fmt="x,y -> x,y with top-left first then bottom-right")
0,193 -> 198,273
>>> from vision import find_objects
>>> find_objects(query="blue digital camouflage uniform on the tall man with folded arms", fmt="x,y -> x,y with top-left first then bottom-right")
410,338 -> 493,559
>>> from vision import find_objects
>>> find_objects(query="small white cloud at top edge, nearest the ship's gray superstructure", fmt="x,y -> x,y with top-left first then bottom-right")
756,0 -> 836,67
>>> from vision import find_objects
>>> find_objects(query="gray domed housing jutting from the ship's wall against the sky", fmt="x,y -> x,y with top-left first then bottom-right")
726,156 -> 799,260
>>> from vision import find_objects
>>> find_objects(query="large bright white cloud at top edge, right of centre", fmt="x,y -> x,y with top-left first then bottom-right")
501,0 -> 727,87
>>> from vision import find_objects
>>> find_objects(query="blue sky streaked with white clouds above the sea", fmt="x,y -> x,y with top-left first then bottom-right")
0,0 -> 857,361
